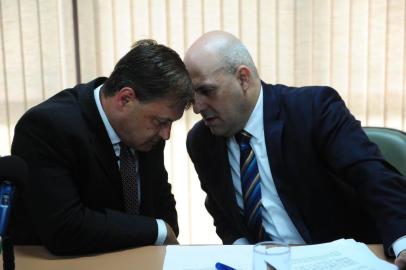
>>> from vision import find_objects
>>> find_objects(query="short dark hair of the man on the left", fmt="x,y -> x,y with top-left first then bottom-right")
103,39 -> 194,108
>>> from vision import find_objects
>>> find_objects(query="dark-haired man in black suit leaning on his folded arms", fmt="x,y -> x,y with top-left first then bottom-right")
11,40 -> 193,255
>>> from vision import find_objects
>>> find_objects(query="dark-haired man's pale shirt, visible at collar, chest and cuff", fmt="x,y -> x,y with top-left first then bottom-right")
94,84 -> 168,245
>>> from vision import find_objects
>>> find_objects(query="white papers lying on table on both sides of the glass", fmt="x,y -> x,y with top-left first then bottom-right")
163,239 -> 397,270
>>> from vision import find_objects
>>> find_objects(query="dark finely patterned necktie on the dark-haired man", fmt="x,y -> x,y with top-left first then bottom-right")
120,142 -> 139,215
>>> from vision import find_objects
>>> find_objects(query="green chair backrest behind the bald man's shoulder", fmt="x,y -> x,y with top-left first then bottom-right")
363,127 -> 406,176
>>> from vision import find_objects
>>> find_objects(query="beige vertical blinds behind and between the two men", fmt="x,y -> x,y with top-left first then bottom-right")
0,0 -> 406,244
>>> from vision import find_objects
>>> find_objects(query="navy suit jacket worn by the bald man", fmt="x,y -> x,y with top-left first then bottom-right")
187,83 -> 406,253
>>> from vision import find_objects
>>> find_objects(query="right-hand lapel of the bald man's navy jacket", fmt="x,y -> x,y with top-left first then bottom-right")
262,83 -> 311,243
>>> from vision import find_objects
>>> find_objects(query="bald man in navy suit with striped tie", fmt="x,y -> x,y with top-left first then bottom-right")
184,31 -> 406,263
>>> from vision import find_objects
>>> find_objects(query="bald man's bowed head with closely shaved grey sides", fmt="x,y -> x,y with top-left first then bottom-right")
184,31 -> 261,137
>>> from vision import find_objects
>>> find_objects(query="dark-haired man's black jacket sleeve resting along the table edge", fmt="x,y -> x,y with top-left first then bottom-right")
12,109 -> 165,255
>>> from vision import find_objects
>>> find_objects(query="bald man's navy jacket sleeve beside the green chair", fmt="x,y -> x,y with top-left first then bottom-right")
312,88 -> 406,251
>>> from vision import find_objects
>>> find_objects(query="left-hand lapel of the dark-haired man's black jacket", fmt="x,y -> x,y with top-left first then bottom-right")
76,78 -> 122,198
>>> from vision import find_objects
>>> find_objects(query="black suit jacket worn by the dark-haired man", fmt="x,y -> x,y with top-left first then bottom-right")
12,78 -> 178,254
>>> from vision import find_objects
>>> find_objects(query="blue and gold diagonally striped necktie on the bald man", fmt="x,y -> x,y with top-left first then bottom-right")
235,130 -> 267,242
